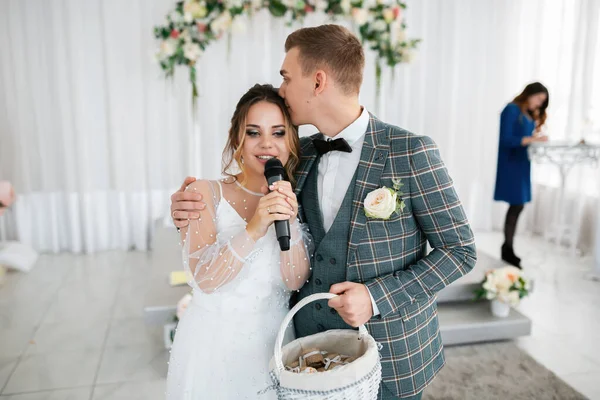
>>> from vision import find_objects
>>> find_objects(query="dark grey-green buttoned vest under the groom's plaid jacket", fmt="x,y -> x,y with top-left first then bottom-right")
292,157 -> 356,337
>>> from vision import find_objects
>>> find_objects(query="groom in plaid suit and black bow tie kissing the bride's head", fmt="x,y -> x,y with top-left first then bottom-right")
171,25 -> 476,399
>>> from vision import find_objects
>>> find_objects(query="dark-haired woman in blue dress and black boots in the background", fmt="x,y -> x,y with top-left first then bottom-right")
494,82 -> 550,268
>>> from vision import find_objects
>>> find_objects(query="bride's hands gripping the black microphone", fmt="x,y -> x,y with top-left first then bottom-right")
246,182 -> 298,241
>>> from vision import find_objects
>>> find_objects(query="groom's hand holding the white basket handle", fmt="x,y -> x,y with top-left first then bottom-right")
328,282 -> 373,328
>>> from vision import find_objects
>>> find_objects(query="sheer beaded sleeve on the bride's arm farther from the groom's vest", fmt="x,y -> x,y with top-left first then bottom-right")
181,181 -> 256,293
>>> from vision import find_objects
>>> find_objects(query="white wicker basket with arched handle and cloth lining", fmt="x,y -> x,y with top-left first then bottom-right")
269,293 -> 381,400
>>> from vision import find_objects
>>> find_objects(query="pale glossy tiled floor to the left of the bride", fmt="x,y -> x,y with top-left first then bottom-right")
0,252 -> 173,400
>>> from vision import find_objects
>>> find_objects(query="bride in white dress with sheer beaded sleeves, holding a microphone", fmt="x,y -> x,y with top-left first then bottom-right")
166,85 -> 310,400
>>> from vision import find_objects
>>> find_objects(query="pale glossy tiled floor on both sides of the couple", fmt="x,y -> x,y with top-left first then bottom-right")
0,233 -> 600,400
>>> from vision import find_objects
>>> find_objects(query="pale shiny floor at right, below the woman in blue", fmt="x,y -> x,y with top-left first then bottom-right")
476,233 -> 600,400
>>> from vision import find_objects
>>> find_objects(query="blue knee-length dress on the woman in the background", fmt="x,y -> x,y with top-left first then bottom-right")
494,103 -> 535,205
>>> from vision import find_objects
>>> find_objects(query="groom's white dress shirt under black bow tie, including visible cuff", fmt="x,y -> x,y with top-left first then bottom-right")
317,107 -> 379,315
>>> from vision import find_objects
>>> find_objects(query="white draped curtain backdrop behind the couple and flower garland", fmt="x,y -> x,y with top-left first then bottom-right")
0,0 -> 600,252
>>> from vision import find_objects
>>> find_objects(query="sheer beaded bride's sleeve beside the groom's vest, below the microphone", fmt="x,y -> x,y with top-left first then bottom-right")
280,221 -> 314,290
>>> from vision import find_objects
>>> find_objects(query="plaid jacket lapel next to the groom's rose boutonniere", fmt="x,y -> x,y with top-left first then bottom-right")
348,114 -> 390,256
